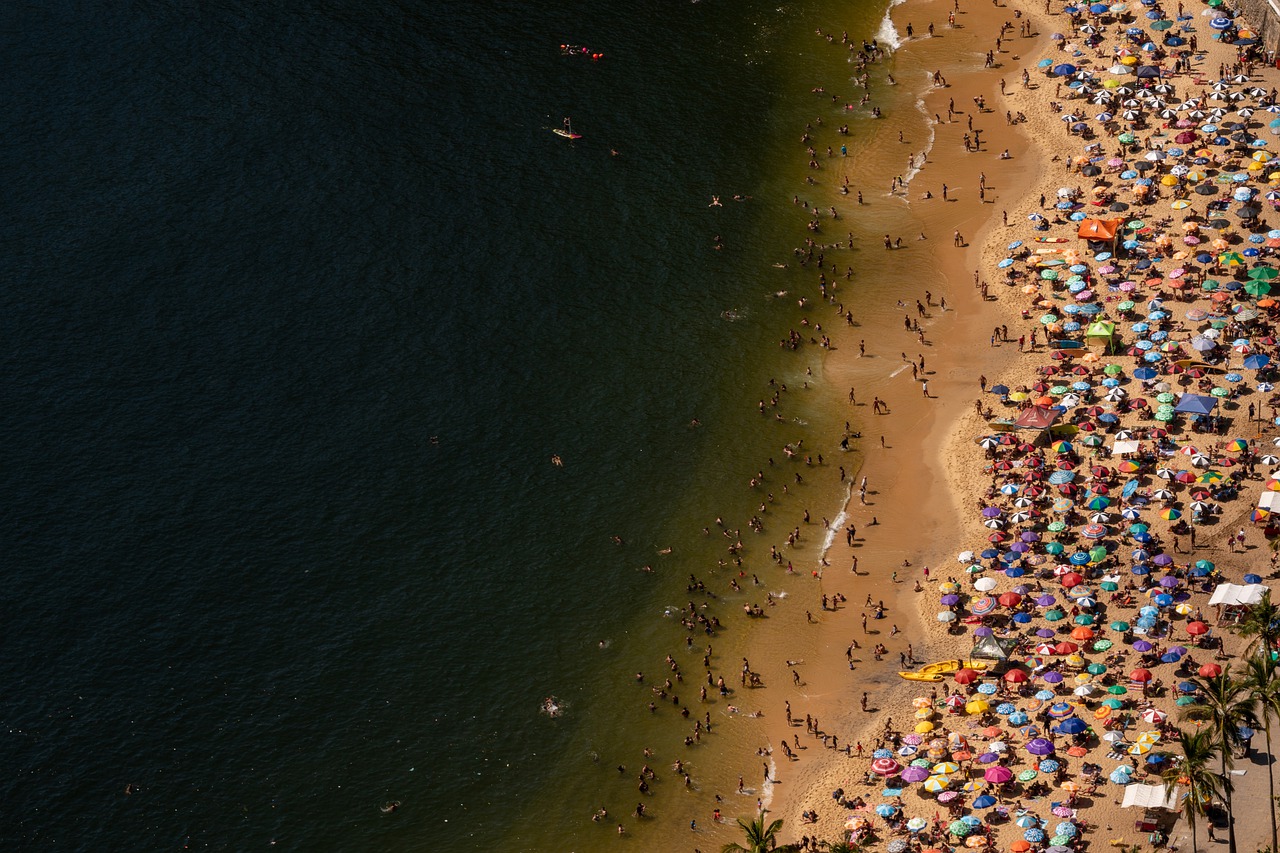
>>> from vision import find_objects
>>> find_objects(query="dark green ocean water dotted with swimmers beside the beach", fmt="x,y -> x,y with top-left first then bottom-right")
0,0 -> 942,850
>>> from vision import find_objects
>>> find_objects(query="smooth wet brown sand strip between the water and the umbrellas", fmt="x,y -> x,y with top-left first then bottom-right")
769,3 -> 1047,840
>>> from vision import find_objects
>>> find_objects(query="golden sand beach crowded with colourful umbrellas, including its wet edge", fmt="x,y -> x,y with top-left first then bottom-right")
711,1 -> 1280,852
